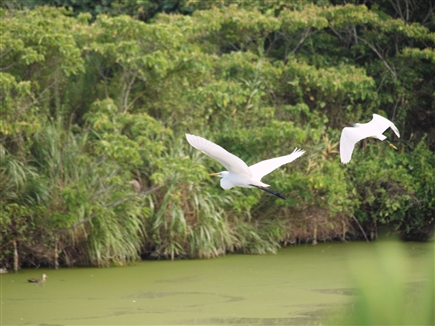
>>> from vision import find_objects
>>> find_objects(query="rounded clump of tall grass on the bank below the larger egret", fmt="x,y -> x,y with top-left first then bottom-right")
147,183 -> 232,259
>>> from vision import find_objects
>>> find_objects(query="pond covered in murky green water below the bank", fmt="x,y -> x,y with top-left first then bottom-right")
1,241 -> 434,325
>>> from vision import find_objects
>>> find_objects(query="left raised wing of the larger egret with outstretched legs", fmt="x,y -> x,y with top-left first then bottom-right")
186,134 -> 251,176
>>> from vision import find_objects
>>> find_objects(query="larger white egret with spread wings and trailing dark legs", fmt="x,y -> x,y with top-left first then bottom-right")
186,134 -> 305,199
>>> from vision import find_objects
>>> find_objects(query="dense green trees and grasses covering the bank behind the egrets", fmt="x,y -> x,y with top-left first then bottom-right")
0,0 -> 435,267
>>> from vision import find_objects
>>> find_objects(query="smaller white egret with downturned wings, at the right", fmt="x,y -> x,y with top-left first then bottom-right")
340,114 -> 400,164
